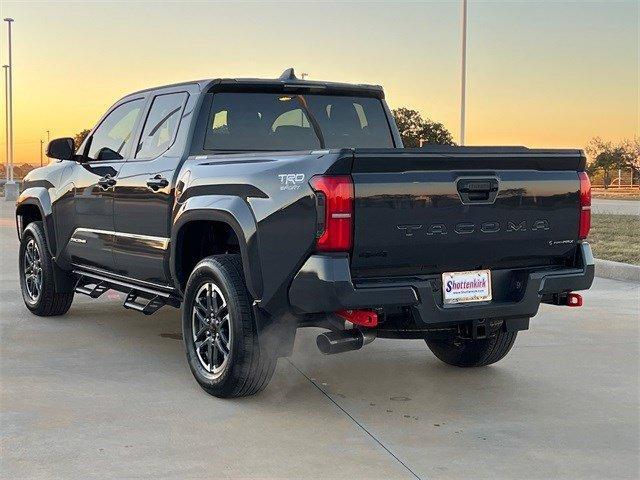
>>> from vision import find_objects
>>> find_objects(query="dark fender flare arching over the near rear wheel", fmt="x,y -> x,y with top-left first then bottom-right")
170,195 -> 263,299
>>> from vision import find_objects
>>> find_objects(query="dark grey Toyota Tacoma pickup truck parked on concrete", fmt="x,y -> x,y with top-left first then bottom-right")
16,69 -> 594,397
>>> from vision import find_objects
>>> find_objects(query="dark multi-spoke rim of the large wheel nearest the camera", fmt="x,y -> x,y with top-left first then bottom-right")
191,283 -> 233,377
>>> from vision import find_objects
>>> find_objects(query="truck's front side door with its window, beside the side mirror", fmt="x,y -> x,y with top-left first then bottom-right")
67,98 -> 145,271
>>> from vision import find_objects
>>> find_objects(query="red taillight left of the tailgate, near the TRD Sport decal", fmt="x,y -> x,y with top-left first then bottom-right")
309,175 -> 353,252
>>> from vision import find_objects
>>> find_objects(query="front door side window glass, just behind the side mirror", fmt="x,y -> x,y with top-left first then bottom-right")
88,99 -> 144,160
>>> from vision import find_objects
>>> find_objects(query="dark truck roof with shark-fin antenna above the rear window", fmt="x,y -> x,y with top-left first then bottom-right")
127,68 -> 384,99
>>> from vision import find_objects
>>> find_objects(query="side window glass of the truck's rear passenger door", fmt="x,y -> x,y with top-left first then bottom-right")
136,93 -> 187,158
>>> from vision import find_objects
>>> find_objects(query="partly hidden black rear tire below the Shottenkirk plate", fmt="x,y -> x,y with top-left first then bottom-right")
425,330 -> 518,367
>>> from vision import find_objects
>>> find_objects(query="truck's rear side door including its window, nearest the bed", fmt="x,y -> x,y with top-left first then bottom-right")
114,87 -> 192,285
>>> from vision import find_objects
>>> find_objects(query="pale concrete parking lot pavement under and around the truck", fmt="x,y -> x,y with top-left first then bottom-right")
0,204 -> 640,480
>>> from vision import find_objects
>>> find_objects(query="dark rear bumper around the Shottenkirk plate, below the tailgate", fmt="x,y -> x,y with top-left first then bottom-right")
289,242 -> 594,324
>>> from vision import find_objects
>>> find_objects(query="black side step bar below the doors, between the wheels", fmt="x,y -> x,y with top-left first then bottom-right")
73,270 -> 181,315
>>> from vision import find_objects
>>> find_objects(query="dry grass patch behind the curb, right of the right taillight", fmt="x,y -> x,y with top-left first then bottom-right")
587,214 -> 640,265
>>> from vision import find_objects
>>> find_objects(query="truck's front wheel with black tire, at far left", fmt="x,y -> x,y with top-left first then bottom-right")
18,222 -> 73,317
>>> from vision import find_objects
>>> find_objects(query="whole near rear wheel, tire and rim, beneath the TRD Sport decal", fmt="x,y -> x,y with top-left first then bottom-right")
182,255 -> 278,398
